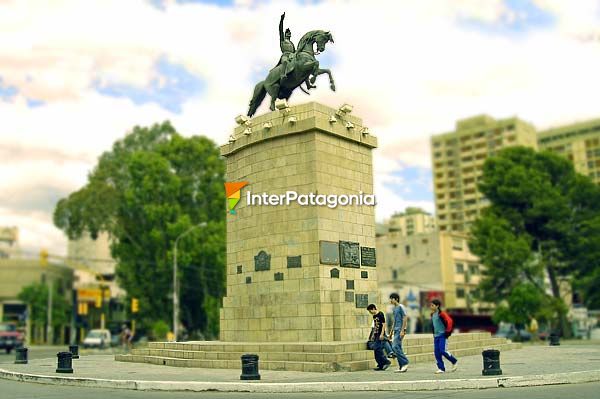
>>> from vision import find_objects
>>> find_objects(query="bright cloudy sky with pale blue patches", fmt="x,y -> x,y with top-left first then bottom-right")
0,0 -> 600,254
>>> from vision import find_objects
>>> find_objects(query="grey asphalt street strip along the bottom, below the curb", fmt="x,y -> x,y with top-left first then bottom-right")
0,380 -> 600,399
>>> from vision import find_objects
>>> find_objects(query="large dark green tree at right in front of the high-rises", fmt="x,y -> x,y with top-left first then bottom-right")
469,147 -> 600,334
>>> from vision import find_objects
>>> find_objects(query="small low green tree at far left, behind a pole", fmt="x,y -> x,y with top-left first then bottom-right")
17,283 -> 71,327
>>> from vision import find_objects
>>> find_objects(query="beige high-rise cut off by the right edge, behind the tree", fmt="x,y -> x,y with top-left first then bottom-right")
538,119 -> 600,184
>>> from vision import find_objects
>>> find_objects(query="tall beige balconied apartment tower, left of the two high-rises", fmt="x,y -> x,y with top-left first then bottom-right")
431,115 -> 537,232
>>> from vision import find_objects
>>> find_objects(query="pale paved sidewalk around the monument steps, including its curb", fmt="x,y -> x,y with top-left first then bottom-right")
0,344 -> 600,392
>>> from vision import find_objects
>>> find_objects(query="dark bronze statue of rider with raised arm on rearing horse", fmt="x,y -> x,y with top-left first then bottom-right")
248,13 -> 335,117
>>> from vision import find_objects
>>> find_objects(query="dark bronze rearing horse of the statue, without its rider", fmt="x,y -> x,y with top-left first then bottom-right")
248,30 -> 335,116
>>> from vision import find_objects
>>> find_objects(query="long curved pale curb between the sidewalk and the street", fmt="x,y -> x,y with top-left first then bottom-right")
0,369 -> 600,393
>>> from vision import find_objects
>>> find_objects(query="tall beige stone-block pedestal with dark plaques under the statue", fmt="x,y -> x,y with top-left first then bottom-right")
220,102 -> 379,342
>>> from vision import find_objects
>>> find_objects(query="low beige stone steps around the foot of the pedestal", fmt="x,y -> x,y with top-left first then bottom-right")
115,333 -> 521,373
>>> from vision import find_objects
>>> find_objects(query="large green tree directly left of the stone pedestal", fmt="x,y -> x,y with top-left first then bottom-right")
54,122 -> 225,338
